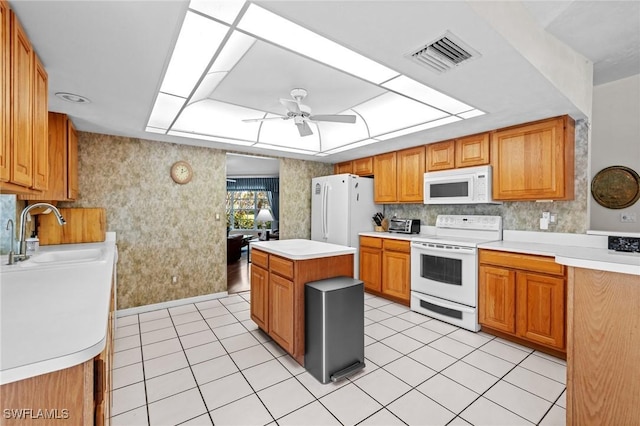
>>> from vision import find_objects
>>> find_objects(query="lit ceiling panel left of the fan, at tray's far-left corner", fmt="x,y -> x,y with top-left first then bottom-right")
172,99 -> 264,141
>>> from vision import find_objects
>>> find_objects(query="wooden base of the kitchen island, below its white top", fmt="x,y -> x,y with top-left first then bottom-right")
251,248 -> 353,365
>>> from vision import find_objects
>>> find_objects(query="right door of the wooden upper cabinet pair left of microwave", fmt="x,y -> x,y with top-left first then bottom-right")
397,146 -> 425,202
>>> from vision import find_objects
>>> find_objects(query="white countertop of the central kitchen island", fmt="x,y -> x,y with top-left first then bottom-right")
250,239 -> 356,260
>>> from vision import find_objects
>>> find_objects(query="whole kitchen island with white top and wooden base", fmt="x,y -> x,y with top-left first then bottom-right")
251,239 -> 364,365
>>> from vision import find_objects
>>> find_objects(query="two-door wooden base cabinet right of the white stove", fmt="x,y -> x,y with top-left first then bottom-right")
478,250 -> 566,357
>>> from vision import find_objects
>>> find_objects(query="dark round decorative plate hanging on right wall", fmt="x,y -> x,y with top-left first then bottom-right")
591,166 -> 640,209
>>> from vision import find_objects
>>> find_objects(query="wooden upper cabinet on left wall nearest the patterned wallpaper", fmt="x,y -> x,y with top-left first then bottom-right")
19,112 -> 78,201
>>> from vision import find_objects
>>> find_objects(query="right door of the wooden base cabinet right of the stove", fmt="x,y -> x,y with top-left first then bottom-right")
516,271 -> 566,349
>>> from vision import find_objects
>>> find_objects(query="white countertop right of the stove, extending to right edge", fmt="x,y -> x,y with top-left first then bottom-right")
478,231 -> 640,278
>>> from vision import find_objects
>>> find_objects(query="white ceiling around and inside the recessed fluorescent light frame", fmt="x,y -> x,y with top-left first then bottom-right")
9,0 -> 640,166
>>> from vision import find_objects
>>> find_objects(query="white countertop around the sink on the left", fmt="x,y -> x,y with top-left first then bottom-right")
0,232 -> 116,384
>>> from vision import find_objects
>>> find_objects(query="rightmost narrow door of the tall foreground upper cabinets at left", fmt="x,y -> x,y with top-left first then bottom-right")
32,53 -> 49,191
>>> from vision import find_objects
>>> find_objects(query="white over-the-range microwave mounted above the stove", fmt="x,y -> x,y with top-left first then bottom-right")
424,166 -> 499,204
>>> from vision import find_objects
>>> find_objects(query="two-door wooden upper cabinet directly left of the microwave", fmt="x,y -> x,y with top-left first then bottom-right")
373,146 -> 425,203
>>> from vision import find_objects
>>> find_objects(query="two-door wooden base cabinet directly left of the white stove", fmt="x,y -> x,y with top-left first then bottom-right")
360,236 -> 411,306
